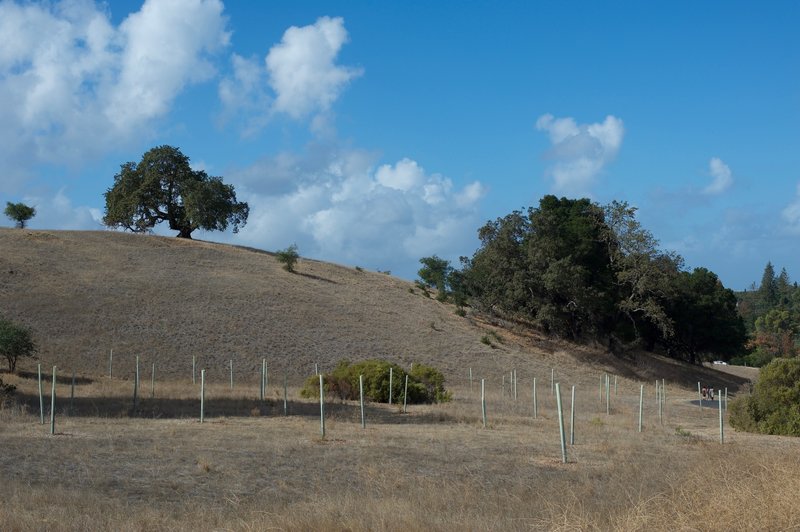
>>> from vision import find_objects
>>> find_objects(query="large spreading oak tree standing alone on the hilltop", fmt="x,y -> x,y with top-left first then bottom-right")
103,146 -> 250,238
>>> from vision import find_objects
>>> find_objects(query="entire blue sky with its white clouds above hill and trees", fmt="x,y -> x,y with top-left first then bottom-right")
0,0 -> 800,289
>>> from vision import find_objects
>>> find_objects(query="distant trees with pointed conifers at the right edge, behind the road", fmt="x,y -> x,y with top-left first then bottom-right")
736,262 -> 800,366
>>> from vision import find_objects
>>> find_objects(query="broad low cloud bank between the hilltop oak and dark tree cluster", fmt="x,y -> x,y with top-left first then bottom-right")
227,150 -> 485,276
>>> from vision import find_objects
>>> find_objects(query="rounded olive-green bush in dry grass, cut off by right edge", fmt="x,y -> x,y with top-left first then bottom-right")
730,358 -> 800,436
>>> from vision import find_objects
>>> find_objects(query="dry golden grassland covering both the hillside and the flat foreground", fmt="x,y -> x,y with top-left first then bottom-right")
0,230 -> 800,530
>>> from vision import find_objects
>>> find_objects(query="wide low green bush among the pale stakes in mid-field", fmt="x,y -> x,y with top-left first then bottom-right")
300,360 -> 451,404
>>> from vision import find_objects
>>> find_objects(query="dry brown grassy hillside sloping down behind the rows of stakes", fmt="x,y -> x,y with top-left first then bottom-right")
0,229 -> 745,388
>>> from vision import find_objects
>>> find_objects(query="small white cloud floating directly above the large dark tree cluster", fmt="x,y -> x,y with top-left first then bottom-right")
536,114 -> 625,196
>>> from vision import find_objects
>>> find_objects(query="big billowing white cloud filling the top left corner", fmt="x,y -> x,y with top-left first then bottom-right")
0,0 -> 228,190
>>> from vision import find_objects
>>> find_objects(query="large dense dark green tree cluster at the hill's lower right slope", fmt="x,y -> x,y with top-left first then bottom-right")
460,196 -> 745,363
